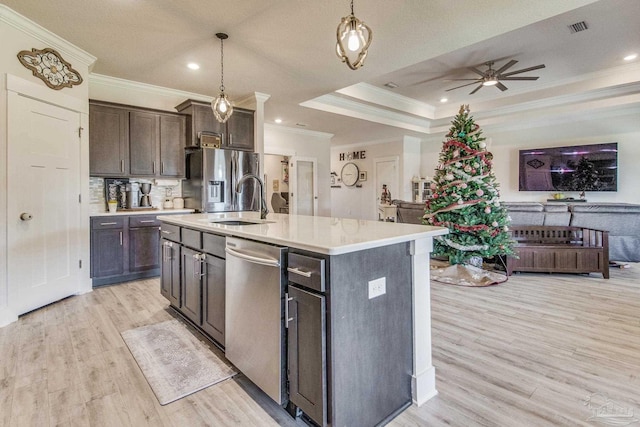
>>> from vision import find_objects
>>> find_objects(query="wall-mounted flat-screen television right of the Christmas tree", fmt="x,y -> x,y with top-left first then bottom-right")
519,142 -> 618,191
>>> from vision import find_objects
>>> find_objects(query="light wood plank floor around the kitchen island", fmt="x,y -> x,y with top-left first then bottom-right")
0,264 -> 640,427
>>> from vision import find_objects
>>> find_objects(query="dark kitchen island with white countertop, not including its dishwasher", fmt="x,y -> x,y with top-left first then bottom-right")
160,212 -> 447,426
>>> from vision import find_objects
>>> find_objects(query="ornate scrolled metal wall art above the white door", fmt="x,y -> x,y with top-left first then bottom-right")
18,48 -> 82,90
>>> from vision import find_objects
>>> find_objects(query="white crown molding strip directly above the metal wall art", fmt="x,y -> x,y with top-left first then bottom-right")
0,4 -> 96,71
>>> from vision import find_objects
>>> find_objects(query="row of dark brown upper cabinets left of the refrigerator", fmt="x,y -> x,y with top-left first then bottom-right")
89,101 -> 186,178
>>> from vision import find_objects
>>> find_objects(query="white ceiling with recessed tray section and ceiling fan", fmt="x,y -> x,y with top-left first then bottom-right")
0,0 -> 640,144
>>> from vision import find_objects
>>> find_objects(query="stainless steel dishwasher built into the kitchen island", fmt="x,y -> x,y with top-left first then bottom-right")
225,237 -> 287,404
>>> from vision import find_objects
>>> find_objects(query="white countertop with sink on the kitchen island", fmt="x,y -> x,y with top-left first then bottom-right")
161,212 -> 448,255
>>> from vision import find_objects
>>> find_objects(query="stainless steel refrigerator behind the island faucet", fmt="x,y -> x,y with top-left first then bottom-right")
182,147 -> 260,212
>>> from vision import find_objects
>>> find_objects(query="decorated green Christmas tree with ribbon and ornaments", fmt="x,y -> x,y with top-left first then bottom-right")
424,105 -> 514,266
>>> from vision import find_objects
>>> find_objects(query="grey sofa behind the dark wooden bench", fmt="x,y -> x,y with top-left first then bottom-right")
502,202 -> 640,262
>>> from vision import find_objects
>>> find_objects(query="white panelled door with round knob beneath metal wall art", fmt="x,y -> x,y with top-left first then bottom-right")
7,92 -> 80,314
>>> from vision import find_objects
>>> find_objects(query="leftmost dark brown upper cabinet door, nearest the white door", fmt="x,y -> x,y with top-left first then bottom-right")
89,103 -> 129,176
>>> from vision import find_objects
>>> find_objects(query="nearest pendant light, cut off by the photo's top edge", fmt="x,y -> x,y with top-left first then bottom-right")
336,0 -> 372,70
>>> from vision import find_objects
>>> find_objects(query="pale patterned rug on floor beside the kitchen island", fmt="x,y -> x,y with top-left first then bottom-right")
121,319 -> 237,405
